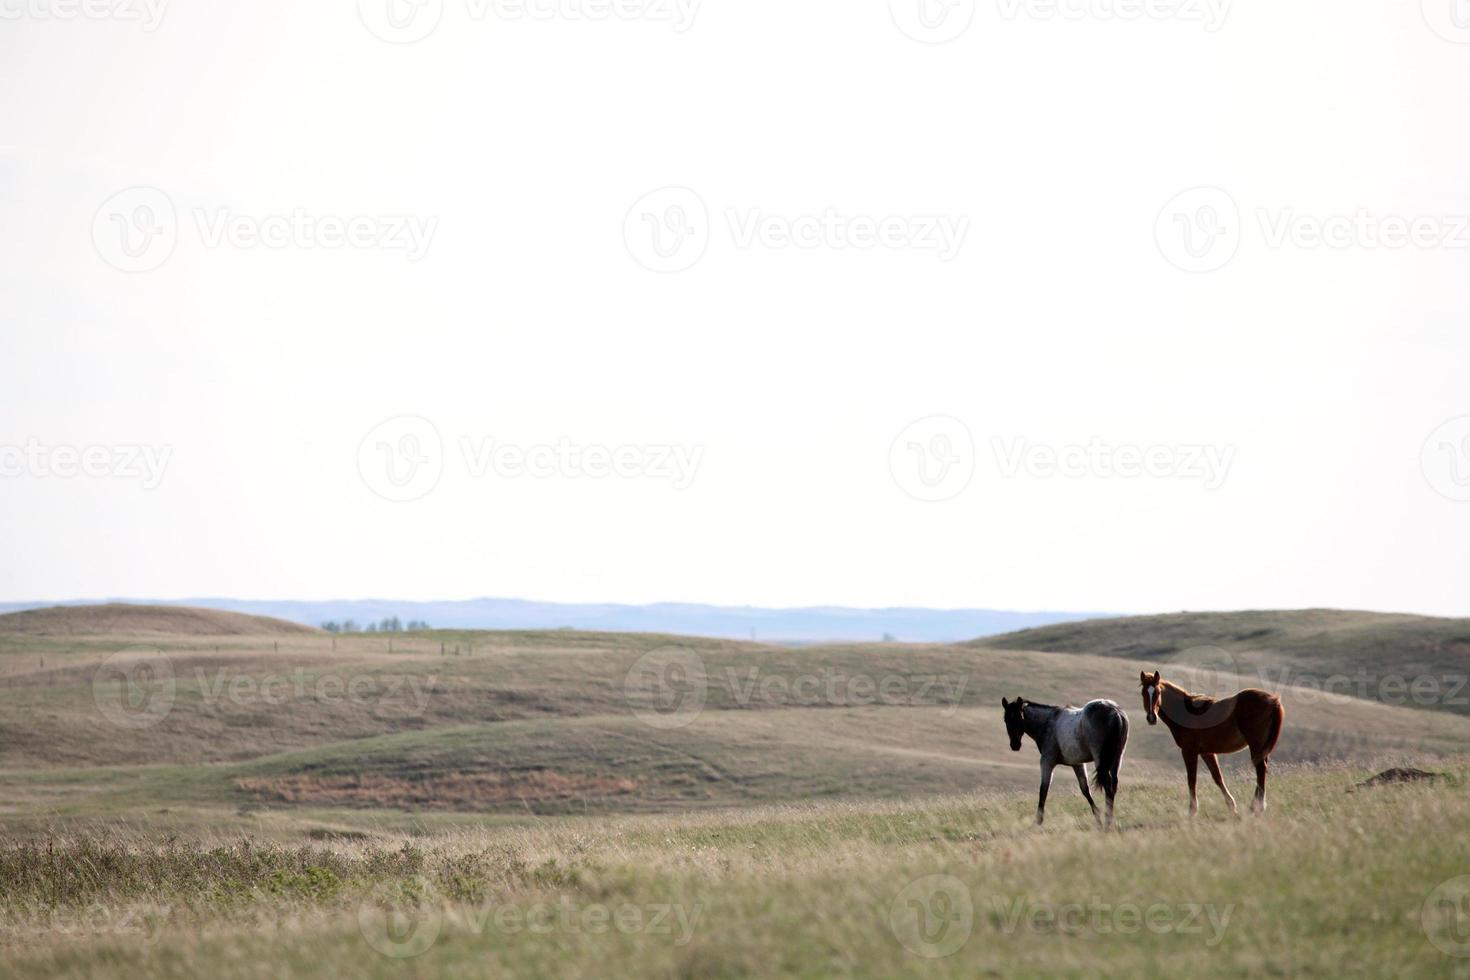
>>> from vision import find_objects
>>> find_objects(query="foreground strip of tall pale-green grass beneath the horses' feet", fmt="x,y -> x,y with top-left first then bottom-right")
0,767 -> 1470,977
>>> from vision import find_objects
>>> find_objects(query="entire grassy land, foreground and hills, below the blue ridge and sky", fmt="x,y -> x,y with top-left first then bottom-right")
0,613 -> 1470,977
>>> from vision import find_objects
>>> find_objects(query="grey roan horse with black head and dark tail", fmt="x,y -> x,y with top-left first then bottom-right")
1001,698 -> 1127,827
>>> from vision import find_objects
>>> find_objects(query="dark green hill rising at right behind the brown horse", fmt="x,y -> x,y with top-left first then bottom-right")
967,610 -> 1470,714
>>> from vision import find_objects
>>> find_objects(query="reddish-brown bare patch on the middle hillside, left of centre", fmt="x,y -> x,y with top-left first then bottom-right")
235,770 -> 638,810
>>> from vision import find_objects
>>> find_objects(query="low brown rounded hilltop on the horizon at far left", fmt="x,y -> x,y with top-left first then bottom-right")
0,602 -> 320,636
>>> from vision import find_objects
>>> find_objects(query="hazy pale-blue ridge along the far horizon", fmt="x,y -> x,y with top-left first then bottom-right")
0,598 -> 1100,644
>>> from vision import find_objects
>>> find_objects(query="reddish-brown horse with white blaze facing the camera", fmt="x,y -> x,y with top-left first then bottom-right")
1138,670 -> 1286,817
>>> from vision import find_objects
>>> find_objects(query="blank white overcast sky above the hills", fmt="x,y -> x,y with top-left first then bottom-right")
0,0 -> 1470,616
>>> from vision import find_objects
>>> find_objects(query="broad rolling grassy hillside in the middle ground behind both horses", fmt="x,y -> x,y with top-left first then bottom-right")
0,623 -> 1470,835
